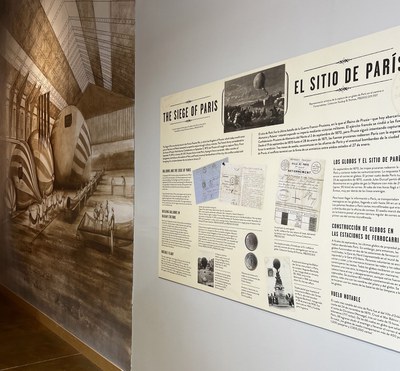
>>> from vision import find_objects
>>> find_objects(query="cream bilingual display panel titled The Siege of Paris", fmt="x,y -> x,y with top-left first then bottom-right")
159,28 -> 400,351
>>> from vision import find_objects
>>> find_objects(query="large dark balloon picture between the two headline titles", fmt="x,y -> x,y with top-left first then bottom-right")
224,65 -> 286,133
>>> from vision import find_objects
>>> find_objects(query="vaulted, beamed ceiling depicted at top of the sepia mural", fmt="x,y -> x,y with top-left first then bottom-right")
1,0 -> 135,117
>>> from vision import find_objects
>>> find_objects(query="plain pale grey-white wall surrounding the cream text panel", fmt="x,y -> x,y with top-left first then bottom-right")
133,0 -> 400,371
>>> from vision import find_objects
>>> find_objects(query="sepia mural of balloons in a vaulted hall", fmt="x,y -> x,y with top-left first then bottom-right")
0,0 -> 135,370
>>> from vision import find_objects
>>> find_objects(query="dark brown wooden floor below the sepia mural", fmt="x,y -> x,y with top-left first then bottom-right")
0,292 -> 100,371
